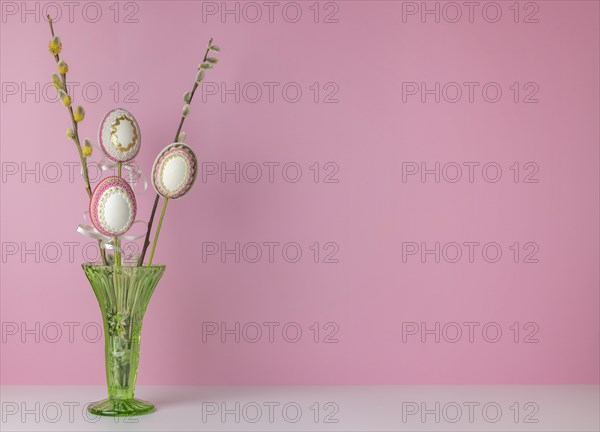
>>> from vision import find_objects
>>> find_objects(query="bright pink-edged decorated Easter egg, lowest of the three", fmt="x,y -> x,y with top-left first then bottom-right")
90,177 -> 137,237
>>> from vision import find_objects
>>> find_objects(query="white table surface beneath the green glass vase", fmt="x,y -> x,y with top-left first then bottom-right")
0,385 -> 600,432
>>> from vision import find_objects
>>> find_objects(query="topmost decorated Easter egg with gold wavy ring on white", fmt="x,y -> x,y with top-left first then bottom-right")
98,108 -> 142,162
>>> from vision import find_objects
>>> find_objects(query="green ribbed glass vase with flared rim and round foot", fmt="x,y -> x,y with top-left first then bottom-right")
82,264 -> 166,416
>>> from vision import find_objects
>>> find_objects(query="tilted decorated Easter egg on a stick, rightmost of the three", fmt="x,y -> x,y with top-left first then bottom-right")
152,143 -> 198,199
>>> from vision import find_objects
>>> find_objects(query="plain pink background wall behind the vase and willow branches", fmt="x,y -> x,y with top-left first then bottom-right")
0,1 -> 600,384
